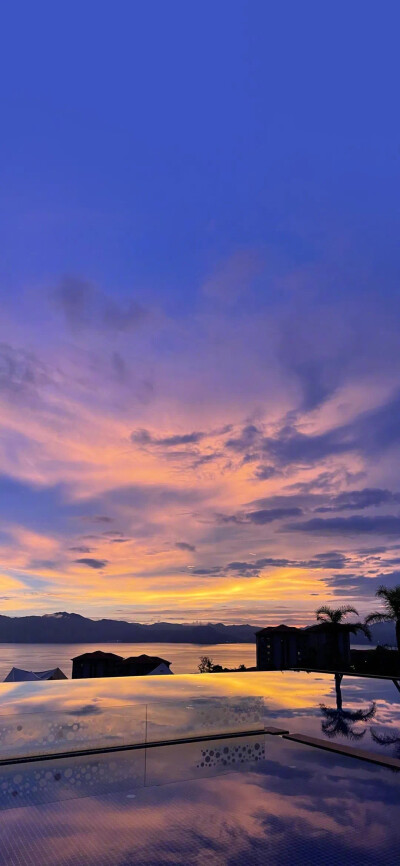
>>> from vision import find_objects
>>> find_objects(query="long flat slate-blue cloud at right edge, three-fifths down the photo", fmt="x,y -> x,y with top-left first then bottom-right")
283,514 -> 400,535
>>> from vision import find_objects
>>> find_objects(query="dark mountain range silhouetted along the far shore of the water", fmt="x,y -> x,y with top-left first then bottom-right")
0,611 -> 260,644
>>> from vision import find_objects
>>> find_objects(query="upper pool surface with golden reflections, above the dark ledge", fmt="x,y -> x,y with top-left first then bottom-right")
0,671 -> 400,756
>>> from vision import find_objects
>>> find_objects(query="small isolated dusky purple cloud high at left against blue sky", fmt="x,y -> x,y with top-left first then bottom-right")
54,276 -> 147,332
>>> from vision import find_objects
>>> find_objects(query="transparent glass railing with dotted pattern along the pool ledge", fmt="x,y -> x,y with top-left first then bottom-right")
0,697 -> 265,761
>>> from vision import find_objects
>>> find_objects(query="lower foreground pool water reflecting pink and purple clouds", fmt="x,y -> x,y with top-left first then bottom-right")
0,737 -> 400,866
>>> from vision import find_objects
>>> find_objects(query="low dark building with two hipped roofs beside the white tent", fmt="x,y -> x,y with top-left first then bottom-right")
72,650 -> 173,679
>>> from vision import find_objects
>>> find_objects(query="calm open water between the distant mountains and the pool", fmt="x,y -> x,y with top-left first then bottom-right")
0,643 -> 256,681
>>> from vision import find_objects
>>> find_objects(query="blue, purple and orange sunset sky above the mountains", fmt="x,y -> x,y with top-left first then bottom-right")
0,0 -> 400,625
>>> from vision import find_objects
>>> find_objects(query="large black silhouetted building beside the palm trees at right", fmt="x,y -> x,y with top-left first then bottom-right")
256,623 -> 350,671
